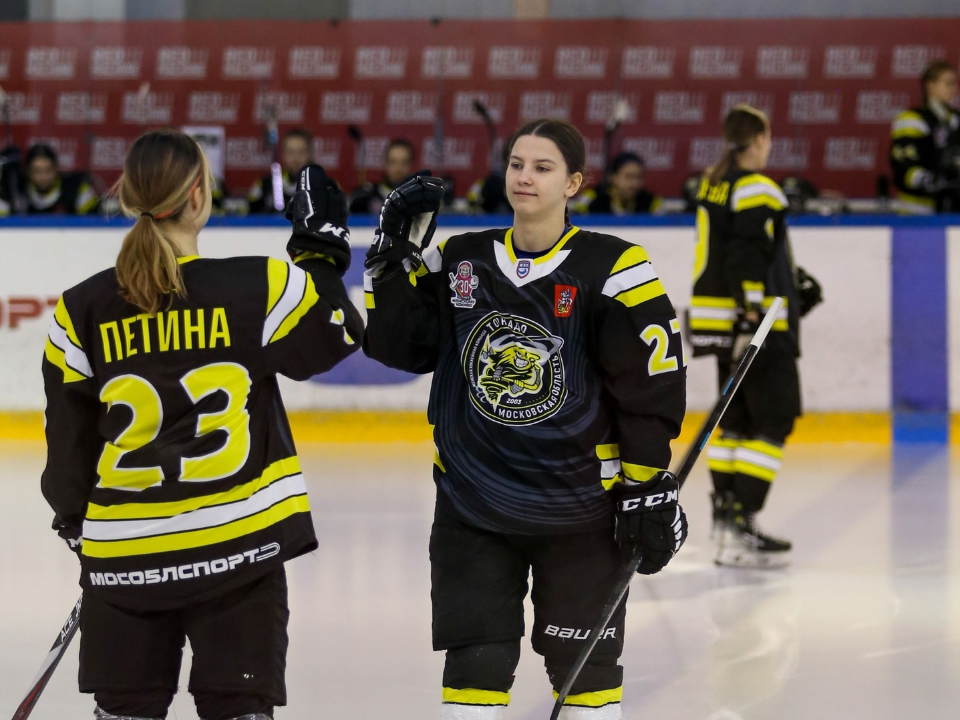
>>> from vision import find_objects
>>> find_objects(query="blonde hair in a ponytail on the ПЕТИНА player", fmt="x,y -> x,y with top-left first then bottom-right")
115,130 -> 213,315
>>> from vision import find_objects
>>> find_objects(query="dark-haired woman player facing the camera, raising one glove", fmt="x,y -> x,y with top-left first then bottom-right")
364,120 -> 687,720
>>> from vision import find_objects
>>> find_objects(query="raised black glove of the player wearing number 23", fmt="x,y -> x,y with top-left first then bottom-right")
285,163 -> 350,276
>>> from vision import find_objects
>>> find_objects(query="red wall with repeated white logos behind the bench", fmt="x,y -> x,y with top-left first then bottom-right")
0,19 -> 960,196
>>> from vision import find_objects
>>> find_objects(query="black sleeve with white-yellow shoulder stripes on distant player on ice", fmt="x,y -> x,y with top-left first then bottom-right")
724,174 -> 788,310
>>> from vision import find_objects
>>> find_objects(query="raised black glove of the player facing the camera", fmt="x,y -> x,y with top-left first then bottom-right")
364,175 -> 443,272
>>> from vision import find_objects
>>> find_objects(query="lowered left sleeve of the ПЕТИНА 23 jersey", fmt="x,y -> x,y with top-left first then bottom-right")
40,297 -> 103,537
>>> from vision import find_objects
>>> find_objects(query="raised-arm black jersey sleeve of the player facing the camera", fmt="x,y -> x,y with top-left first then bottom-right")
363,262 -> 440,374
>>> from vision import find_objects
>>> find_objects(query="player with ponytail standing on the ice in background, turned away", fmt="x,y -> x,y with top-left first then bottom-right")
689,105 -> 820,567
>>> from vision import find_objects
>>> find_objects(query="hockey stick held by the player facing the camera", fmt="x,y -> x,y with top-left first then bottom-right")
550,298 -> 783,720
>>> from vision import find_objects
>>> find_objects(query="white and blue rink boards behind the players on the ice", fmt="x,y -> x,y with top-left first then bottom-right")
0,217 -> 960,434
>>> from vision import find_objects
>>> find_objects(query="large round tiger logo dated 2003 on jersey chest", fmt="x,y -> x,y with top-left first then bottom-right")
463,312 -> 566,425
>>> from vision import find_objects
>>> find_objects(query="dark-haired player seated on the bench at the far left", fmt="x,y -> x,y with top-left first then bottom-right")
0,143 -> 100,216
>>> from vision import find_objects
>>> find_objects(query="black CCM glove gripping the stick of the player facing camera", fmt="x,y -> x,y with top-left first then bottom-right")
614,470 -> 687,575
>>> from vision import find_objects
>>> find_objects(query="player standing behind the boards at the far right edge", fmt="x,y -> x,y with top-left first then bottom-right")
890,60 -> 960,215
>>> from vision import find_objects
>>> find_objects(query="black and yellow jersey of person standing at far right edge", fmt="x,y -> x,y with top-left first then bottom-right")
890,103 -> 960,215
